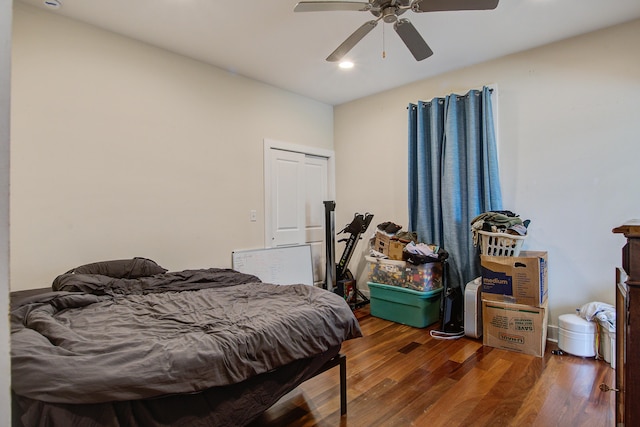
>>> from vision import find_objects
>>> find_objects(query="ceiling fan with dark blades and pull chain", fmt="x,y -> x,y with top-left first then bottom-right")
293,0 -> 498,62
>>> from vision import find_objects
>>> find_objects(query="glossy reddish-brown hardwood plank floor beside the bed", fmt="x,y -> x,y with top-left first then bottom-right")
252,307 -> 615,427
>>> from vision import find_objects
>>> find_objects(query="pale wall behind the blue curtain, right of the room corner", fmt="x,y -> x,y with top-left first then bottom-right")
334,20 -> 640,325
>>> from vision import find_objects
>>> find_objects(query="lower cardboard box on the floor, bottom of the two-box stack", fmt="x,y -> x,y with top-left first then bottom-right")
482,300 -> 549,357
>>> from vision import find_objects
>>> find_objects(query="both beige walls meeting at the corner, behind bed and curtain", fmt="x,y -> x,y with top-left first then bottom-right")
11,3 -> 640,334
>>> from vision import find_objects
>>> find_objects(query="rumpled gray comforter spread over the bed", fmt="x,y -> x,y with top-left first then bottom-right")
11,269 -> 361,403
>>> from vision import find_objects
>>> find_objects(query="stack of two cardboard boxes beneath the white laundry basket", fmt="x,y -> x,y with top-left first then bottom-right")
480,251 -> 549,357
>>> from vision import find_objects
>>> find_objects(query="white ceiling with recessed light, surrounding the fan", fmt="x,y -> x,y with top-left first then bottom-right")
20,0 -> 640,105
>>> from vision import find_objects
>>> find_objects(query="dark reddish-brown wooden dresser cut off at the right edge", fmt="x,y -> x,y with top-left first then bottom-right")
613,220 -> 640,426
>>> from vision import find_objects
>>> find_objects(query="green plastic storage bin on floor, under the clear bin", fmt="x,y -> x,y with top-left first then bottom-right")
368,282 -> 442,328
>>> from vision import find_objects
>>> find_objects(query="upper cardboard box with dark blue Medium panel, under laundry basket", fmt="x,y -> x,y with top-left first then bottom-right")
480,251 -> 549,307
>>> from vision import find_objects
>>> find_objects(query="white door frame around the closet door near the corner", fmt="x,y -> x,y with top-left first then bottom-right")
263,138 -> 336,248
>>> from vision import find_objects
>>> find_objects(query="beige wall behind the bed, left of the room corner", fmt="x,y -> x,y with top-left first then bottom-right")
11,2 -> 333,290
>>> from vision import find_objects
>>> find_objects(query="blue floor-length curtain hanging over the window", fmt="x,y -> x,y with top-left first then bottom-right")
408,87 -> 502,289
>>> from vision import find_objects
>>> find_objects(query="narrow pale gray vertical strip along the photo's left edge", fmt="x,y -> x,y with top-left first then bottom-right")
0,1 -> 12,426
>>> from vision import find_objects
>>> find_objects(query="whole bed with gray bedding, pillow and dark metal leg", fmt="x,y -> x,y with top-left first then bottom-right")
10,258 -> 362,426
